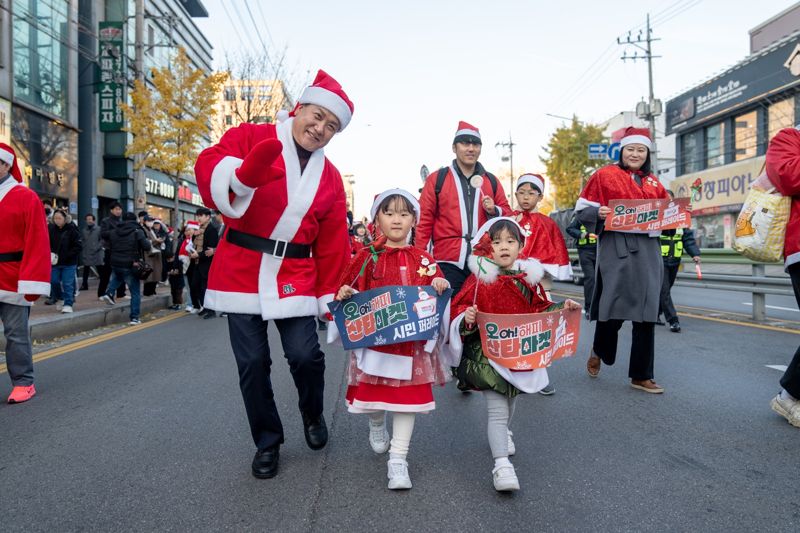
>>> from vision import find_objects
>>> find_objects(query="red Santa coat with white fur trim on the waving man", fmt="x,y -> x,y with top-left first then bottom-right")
195,119 -> 350,320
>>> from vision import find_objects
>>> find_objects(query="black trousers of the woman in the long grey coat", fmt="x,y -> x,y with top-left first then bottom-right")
592,320 -> 655,380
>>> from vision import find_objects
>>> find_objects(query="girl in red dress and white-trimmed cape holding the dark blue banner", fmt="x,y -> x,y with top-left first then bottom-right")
329,189 -> 450,489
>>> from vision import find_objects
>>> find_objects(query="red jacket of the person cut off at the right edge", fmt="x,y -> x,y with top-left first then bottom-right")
767,128 -> 800,268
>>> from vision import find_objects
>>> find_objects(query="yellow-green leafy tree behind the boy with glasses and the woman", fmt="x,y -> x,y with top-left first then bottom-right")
540,116 -> 608,209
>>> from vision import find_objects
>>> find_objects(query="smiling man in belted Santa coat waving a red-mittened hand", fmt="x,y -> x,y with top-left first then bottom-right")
195,70 -> 353,478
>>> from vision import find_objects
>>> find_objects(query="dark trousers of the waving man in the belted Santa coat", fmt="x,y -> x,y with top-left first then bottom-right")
228,313 -> 325,450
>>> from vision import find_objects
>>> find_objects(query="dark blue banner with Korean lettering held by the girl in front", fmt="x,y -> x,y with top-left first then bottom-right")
324,285 -> 453,350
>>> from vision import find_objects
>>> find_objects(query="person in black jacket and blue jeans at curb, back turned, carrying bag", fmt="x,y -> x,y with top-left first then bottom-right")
101,213 -> 152,326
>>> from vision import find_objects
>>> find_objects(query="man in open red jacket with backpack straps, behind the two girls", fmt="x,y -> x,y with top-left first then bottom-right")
415,121 -> 511,295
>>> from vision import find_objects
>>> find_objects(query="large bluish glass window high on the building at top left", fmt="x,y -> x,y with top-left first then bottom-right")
12,0 -> 73,119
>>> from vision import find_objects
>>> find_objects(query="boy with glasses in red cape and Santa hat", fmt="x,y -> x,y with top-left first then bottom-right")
514,174 -> 572,396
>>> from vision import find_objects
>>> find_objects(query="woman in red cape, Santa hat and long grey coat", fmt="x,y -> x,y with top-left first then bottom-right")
575,127 -> 669,394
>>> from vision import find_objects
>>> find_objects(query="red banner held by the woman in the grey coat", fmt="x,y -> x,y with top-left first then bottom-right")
605,198 -> 692,231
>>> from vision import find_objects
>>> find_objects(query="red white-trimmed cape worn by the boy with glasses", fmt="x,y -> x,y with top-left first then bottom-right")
514,211 -> 572,279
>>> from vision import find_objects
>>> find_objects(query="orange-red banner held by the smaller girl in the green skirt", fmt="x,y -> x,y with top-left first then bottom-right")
478,309 -> 582,370
